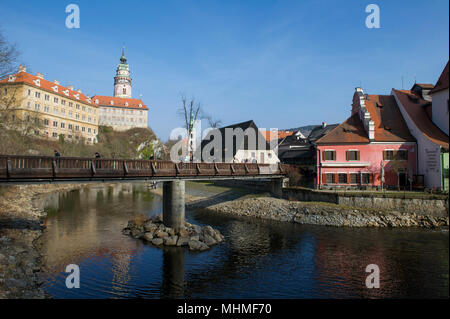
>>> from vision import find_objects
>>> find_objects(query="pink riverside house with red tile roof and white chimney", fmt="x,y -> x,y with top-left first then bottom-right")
316,88 -> 417,187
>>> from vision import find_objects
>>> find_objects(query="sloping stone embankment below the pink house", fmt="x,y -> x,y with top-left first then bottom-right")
192,197 -> 449,228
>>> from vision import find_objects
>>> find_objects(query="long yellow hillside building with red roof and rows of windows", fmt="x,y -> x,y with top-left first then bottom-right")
0,66 -> 98,144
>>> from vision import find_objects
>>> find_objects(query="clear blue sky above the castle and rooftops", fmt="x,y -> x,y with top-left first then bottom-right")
0,0 -> 449,141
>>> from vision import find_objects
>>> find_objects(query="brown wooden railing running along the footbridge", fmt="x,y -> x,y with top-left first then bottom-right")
0,155 -> 284,181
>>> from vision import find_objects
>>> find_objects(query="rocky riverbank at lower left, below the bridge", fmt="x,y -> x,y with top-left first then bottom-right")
0,184 -> 92,299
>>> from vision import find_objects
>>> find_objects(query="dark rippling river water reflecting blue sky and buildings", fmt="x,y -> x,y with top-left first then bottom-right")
40,184 -> 449,298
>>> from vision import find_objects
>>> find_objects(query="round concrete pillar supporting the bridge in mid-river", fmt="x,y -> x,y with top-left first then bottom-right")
163,181 -> 185,229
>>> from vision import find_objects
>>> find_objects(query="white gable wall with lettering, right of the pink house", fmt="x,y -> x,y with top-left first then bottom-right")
392,93 -> 441,188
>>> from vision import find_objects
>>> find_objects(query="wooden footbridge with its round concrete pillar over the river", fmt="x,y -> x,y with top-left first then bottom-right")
0,155 -> 285,228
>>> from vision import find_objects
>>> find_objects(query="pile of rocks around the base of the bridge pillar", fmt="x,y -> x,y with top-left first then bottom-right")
122,215 -> 225,251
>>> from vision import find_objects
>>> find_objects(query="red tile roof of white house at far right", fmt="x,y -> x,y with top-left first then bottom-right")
392,90 -> 449,149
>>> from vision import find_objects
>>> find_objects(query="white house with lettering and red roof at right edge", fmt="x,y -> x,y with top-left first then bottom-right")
392,63 -> 449,191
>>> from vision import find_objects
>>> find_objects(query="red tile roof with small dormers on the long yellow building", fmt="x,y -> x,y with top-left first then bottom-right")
0,72 -> 92,104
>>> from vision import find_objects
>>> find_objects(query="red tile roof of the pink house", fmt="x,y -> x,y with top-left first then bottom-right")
316,93 -> 416,144
